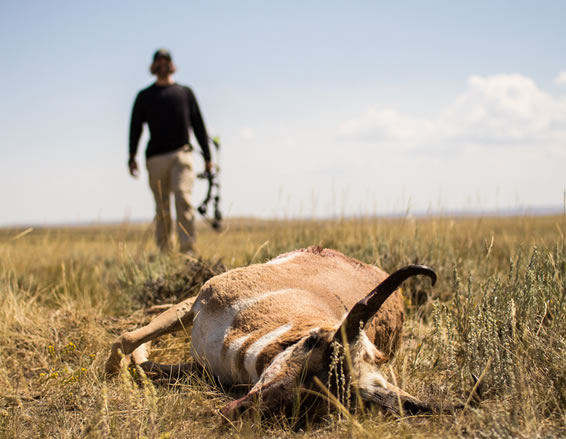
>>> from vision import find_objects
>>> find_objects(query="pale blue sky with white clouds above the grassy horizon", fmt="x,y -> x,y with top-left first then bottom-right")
0,1 -> 566,225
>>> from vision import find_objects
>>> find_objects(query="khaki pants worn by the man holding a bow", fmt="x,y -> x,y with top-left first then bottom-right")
146,146 -> 195,252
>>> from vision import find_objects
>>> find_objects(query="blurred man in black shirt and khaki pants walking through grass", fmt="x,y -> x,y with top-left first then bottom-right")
128,49 -> 212,253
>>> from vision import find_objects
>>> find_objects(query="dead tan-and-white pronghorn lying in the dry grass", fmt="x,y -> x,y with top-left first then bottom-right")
106,247 -> 460,417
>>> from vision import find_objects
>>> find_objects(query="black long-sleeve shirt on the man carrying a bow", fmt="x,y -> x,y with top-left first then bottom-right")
130,83 -> 210,160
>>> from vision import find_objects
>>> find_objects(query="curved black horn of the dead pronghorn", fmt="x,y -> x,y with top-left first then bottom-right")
334,265 -> 436,343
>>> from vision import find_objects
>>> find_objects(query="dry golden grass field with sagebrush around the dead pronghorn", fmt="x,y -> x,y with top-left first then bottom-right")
0,216 -> 566,438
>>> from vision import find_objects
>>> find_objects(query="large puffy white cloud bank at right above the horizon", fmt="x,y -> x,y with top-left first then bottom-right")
340,74 -> 566,151
